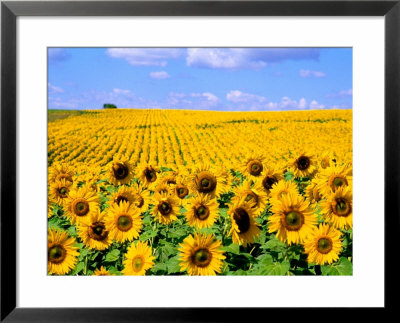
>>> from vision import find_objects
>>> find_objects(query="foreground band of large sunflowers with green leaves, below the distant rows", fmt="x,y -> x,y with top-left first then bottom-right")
48,147 -> 352,275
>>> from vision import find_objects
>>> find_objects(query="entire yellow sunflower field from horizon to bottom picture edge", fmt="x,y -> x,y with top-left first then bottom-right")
48,109 -> 353,275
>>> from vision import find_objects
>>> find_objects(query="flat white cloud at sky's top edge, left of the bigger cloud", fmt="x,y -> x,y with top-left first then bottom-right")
106,48 -> 184,66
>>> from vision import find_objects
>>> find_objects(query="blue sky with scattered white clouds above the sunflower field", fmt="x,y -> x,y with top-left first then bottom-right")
48,48 -> 353,111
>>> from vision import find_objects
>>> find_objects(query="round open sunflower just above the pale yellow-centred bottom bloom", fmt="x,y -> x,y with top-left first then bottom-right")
105,201 -> 142,243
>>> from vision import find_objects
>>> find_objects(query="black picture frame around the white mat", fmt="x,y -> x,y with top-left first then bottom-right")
0,0 -> 400,322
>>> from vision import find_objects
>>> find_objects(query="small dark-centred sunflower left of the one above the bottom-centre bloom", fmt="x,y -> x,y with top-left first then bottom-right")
153,193 -> 180,224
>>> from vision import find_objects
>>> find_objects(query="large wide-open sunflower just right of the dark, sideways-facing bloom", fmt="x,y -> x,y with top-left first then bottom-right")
268,194 -> 317,245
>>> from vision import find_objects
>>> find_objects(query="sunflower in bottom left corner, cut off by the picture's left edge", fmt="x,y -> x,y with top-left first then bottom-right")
47,230 -> 79,275
